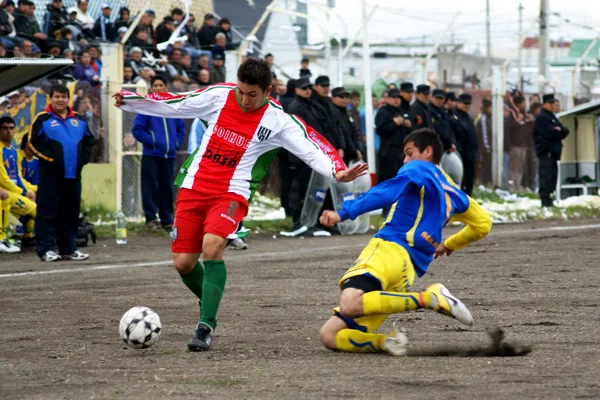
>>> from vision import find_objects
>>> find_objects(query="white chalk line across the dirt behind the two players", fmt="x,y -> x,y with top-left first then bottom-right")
0,224 -> 600,279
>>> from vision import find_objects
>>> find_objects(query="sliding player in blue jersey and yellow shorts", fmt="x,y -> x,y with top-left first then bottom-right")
321,129 -> 492,355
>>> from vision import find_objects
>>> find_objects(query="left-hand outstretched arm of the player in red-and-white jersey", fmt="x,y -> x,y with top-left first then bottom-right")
113,85 -> 230,119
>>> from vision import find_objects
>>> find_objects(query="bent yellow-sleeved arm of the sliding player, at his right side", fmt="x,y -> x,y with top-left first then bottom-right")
435,197 -> 492,258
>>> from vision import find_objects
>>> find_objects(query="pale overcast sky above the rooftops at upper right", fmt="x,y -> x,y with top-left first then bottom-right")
309,0 -> 600,52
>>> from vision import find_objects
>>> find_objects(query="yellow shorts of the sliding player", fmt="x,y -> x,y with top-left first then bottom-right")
333,238 -> 416,333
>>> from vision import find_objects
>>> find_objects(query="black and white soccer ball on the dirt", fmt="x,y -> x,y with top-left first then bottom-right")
119,306 -> 162,349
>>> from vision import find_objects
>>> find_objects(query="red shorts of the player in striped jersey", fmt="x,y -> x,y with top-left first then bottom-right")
171,188 -> 248,253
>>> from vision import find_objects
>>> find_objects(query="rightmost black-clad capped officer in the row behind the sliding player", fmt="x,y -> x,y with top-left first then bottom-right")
454,93 -> 477,196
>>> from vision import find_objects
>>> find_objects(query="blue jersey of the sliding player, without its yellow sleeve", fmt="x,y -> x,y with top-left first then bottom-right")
339,160 -> 478,277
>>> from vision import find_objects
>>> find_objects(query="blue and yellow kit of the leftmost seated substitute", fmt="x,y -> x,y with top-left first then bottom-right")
0,144 -> 37,240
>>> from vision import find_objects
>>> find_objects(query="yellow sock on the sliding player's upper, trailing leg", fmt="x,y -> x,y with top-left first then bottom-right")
362,292 -> 433,315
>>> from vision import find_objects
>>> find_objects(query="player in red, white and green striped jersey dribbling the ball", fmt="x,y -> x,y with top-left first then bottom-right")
114,58 -> 366,351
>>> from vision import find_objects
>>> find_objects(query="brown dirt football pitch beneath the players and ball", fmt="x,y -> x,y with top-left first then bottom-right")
0,220 -> 600,400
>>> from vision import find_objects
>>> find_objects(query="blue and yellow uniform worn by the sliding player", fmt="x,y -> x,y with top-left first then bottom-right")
334,161 -> 492,352
